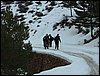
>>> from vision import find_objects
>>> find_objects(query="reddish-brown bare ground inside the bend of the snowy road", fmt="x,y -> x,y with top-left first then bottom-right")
28,53 -> 71,74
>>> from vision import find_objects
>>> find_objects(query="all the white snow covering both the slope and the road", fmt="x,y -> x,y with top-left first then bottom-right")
1,1 -> 99,75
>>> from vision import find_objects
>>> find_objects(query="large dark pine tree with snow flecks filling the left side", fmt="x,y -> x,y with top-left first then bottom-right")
1,7 -> 32,74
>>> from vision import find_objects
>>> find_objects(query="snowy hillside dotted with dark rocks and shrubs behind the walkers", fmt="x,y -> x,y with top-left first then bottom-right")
1,1 -> 98,46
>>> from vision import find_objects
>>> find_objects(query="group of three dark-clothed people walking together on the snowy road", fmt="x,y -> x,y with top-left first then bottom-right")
43,34 -> 61,50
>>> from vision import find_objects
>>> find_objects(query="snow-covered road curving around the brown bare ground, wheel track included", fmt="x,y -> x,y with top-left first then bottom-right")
34,46 -> 99,75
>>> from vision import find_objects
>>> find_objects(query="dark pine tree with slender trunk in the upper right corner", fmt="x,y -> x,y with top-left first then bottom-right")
73,1 -> 99,38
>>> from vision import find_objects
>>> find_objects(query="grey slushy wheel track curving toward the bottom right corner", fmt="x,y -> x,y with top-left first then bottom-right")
62,51 -> 99,75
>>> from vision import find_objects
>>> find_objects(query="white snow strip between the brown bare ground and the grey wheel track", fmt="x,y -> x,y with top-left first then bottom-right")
34,48 -> 90,75
